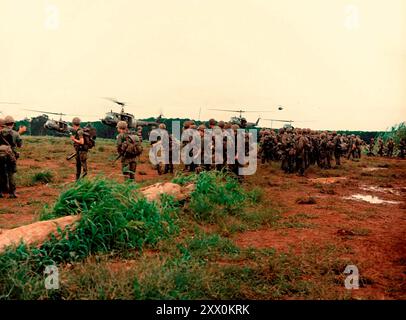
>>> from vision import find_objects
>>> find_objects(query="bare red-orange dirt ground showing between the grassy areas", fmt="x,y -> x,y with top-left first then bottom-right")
0,154 -> 406,299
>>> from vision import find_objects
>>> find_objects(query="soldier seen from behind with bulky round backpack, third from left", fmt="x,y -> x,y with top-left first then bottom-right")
117,121 -> 142,181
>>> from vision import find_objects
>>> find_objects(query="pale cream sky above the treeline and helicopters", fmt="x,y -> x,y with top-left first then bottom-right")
0,0 -> 406,130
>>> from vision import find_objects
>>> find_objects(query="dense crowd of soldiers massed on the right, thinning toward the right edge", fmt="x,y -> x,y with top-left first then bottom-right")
259,128 -> 405,175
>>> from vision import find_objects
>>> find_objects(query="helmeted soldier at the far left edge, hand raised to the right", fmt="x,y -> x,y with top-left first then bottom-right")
0,116 -> 27,198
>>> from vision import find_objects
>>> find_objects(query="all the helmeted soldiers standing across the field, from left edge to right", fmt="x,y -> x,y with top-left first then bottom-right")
0,116 -> 406,198
